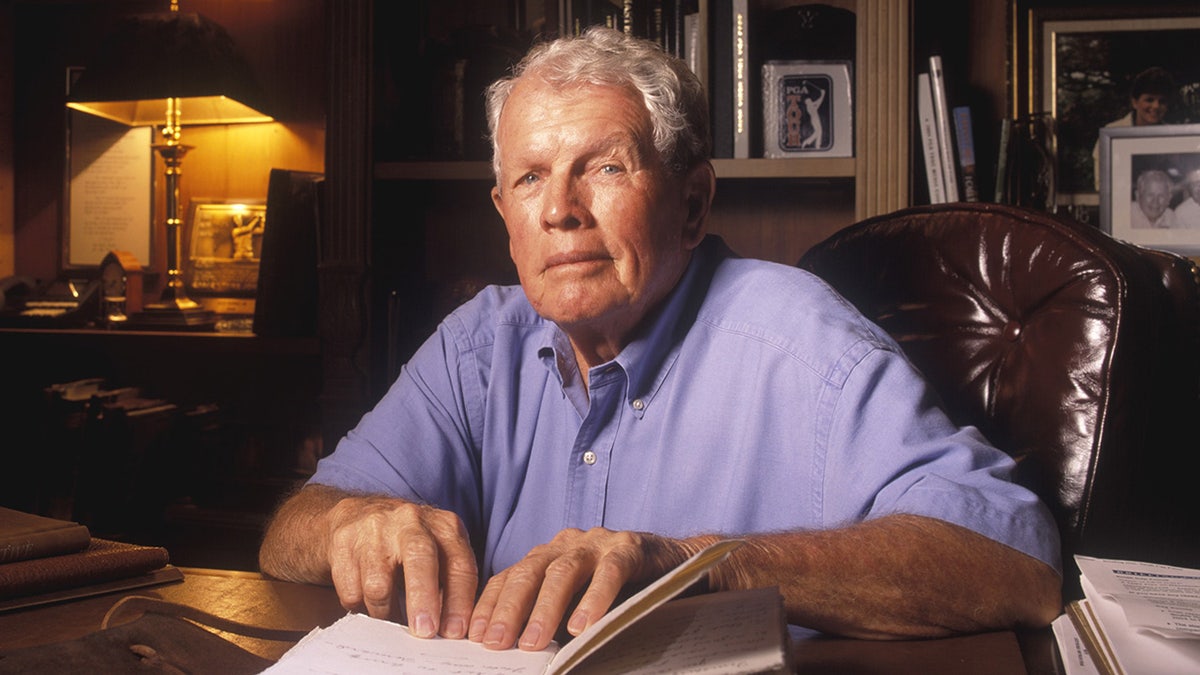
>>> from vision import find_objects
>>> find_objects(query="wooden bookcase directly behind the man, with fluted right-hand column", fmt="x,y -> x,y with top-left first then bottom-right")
320,0 -> 913,422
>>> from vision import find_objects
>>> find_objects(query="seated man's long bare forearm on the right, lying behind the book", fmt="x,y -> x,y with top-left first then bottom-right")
710,515 -> 1062,638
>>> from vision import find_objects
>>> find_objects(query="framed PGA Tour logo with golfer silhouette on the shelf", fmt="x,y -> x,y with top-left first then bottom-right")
762,61 -> 854,157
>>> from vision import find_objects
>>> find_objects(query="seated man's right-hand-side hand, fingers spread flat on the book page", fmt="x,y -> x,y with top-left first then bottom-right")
468,527 -> 702,650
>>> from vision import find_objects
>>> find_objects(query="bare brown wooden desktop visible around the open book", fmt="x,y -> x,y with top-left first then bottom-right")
0,568 -> 1055,675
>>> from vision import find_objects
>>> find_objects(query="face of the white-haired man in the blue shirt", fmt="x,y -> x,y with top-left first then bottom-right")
492,77 -> 701,336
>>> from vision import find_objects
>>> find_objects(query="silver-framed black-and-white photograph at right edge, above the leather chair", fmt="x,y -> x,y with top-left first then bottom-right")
1099,124 -> 1200,256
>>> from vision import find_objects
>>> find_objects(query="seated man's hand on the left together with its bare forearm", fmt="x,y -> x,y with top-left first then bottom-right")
259,485 -> 479,638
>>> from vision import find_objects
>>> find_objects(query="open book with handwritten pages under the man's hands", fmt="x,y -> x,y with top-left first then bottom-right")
266,539 -> 791,675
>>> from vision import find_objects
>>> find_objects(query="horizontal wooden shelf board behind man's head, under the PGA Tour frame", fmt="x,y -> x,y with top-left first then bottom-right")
374,157 -> 856,180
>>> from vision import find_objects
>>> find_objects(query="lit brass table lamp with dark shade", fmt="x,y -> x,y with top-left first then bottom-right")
67,0 -> 272,330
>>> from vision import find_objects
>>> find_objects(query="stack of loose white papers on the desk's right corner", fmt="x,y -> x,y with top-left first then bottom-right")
1054,555 -> 1200,675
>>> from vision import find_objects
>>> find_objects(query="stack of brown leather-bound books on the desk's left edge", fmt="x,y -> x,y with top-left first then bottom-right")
0,507 -> 182,611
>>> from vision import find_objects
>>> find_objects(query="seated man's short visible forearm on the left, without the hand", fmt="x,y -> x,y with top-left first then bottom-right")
258,485 -> 349,584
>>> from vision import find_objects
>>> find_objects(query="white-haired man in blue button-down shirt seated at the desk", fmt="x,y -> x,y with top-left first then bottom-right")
260,29 -> 1061,650
